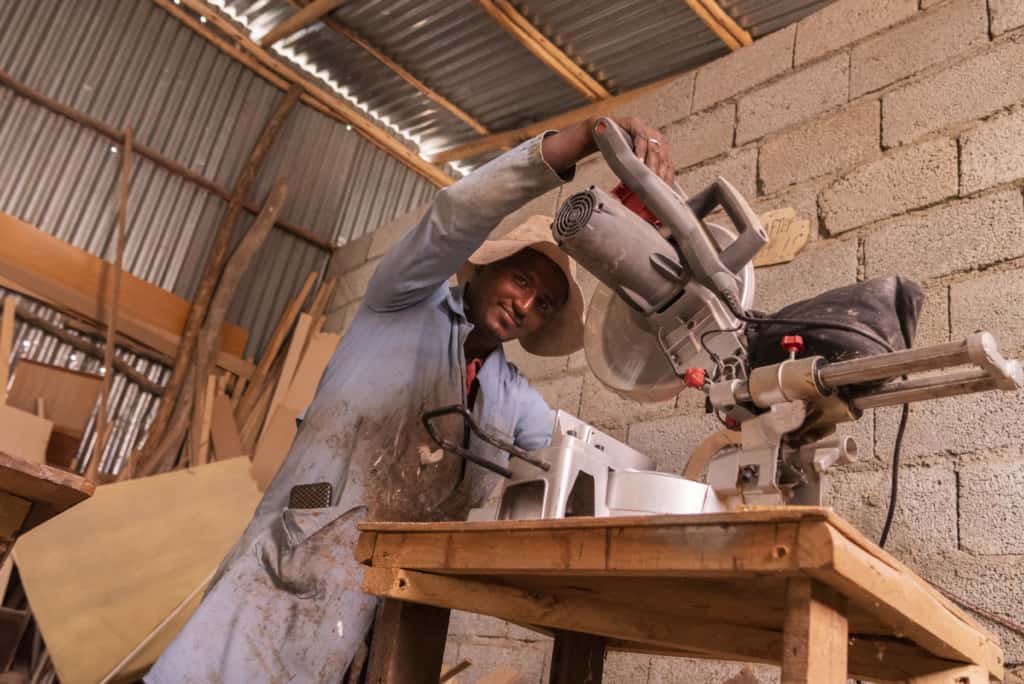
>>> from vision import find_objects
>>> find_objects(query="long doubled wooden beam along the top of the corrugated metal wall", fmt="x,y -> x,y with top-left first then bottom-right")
153,0 -> 454,187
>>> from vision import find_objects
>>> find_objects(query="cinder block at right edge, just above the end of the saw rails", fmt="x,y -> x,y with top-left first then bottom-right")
949,270 -> 1024,354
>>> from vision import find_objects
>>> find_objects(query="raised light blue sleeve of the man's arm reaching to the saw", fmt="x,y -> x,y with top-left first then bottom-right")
366,131 -> 574,312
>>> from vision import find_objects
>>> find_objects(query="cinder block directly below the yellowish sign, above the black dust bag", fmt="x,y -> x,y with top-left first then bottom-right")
755,235 -> 857,311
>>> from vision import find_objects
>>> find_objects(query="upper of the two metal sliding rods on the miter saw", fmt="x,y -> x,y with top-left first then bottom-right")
818,340 -> 971,389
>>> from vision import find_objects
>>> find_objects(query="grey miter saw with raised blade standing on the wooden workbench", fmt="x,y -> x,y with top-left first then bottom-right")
423,119 -> 1024,519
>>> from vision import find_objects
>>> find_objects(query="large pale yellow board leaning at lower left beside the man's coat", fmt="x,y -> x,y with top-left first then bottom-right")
13,459 -> 260,684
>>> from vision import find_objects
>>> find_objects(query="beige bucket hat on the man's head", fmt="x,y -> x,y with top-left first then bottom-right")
458,216 -> 584,356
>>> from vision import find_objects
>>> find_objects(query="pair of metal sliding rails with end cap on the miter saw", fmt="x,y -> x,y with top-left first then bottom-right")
817,333 -> 1024,411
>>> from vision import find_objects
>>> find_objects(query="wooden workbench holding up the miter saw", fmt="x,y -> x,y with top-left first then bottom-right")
356,507 -> 1004,684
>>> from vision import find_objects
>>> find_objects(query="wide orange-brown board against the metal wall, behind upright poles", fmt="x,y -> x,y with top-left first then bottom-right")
0,213 -> 249,356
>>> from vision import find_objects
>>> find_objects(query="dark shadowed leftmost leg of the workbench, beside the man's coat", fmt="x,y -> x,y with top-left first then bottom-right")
367,599 -> 451,684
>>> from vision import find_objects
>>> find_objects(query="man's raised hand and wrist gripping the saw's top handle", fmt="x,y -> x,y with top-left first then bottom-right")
542,117 -> 675,185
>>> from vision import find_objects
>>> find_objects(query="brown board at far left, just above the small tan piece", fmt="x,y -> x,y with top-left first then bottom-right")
8,358 -> 102,436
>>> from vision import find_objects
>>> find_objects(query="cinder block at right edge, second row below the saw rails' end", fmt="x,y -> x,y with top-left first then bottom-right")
959,461 -> 1024,555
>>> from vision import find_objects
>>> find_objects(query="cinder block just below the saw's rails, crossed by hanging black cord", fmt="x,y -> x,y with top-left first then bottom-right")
874,392 -> 1024,463
